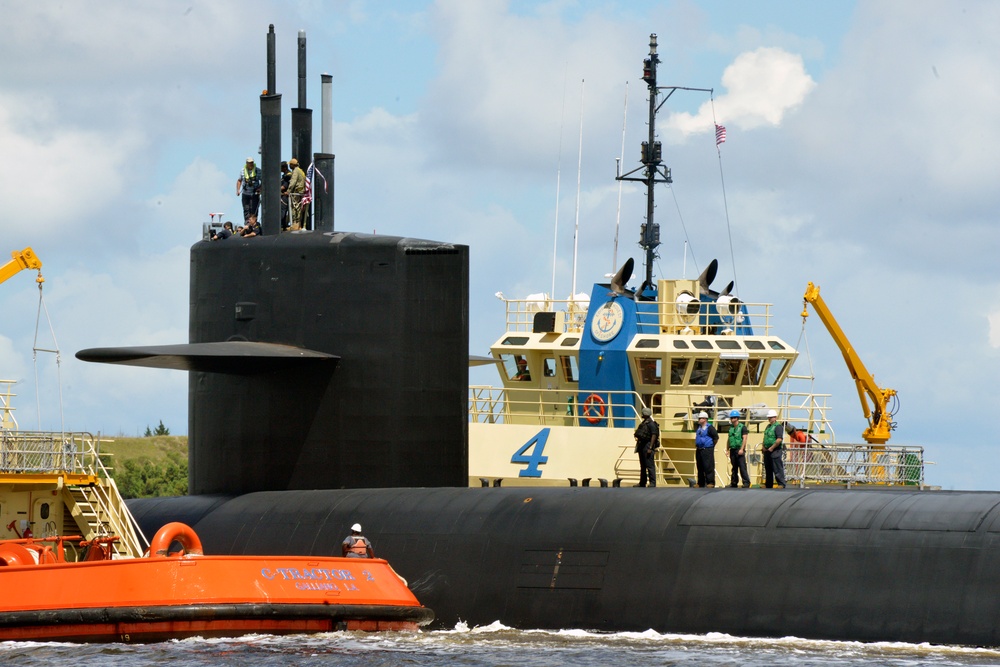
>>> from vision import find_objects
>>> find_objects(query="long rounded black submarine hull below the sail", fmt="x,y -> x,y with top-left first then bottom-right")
129,487 -> 1000,646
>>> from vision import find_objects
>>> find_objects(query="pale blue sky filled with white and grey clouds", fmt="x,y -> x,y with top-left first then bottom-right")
0,0 -> 1000,489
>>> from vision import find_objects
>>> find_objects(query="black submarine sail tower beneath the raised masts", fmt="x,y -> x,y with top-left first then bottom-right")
188,232 -> 469,494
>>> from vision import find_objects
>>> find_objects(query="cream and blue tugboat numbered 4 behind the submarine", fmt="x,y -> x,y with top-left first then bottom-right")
469,34 -> 924,487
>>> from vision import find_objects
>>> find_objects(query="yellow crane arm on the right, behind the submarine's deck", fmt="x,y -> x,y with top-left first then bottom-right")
802,283 -> 896,445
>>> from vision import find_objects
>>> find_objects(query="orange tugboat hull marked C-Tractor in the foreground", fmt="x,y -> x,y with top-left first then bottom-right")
0,523 -> 434,642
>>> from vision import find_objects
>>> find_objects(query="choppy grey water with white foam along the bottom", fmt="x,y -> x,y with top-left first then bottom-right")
0,623 -> 1000,667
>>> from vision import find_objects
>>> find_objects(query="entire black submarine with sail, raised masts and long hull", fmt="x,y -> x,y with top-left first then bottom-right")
77,26 -> 1000,646
